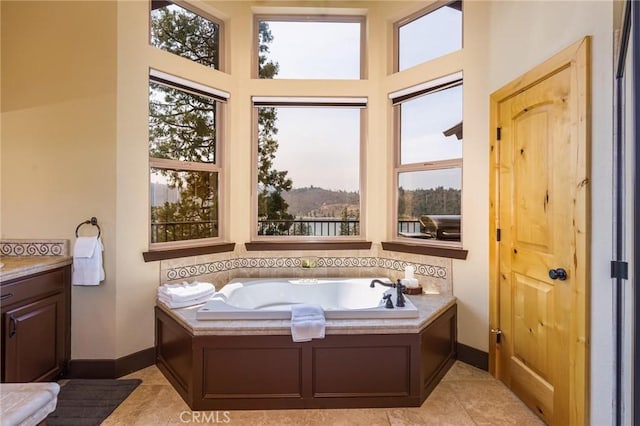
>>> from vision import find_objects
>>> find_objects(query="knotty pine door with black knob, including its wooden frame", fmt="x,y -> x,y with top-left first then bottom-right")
490,38 -> 589,425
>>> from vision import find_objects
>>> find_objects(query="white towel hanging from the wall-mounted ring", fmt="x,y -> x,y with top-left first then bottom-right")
71,237 -> 104,285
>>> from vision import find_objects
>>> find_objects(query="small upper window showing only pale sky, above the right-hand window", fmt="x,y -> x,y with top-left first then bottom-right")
395,1 -> 462,71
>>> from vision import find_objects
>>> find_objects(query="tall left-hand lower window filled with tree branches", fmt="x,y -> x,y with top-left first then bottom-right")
149,70 -> 228,247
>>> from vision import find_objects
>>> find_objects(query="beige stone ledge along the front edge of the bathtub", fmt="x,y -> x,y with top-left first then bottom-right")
157,294 -> 456,336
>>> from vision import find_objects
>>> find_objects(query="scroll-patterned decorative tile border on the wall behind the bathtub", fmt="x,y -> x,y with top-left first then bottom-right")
166,257 -> 447,280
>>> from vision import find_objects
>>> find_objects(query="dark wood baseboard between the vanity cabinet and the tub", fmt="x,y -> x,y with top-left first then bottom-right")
68,348 -> 156,379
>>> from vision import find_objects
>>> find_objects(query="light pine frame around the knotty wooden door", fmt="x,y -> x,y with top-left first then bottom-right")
487,37 -> 591,424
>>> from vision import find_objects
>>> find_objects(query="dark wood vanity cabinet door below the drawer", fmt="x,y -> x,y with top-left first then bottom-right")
3,294 -> 64,382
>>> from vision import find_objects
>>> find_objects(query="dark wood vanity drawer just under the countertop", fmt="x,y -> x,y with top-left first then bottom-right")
0,269 -> 64,308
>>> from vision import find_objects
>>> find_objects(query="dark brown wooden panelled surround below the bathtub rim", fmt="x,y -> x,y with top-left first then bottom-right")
156,304 -> 456,410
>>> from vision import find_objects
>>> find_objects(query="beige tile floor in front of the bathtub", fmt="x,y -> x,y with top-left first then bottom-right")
102,362 -> 543,426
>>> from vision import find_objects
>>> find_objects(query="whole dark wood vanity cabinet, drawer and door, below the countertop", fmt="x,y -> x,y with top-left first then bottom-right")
0,266 -> 71,382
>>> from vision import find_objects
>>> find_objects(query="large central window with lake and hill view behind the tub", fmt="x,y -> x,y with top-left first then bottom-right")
253,97 -> 366,240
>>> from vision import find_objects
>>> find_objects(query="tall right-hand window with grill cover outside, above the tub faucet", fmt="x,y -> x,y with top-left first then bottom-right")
390,73 -> 463,245
